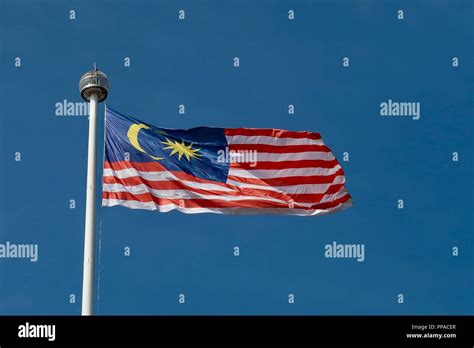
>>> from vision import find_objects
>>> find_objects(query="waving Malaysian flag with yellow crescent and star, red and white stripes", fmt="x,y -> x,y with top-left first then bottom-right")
102,108 -> 351,215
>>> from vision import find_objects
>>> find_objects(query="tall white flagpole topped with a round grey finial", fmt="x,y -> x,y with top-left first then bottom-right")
79,63 -> 109,315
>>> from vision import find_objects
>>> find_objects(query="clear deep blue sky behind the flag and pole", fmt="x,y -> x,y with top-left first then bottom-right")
0,0 -> 474,315
